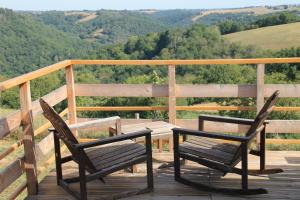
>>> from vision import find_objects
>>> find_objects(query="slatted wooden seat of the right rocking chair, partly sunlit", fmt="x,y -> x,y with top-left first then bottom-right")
179,136 -> 240,165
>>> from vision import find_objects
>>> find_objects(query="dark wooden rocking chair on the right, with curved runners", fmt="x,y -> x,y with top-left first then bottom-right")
173,91 -> 282,194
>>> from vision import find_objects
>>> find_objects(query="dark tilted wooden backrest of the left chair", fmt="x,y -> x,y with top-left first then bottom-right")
40,99 -> 95,170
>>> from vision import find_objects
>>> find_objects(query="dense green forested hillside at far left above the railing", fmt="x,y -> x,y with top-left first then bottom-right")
0,9 -> 99,77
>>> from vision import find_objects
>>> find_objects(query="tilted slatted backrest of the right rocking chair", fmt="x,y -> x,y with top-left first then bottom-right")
231,90 -> 279,166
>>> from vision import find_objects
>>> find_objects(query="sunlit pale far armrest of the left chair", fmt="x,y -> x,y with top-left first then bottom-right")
48,116 -> 121,132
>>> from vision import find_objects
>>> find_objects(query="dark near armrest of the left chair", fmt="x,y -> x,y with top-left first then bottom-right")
74,129 -> 152,149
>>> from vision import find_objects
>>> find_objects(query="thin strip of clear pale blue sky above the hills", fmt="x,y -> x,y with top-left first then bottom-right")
0,0 -> 300,10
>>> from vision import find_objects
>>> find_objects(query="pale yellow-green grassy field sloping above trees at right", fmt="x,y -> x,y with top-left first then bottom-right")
224,22 -> 300,50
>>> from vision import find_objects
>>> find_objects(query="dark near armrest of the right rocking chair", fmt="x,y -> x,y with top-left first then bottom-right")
172,128 -> 251,142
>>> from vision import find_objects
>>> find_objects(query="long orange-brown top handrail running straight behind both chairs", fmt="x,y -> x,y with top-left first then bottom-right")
71,57 -> 300,66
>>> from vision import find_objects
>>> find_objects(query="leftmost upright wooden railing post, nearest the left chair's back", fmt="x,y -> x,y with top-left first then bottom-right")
20,81 -> 38,195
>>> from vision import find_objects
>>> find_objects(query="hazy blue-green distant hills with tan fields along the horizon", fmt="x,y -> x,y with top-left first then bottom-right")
29,5 -> 300,44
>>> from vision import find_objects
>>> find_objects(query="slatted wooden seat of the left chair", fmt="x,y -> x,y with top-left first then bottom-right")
85,140 -> 146,171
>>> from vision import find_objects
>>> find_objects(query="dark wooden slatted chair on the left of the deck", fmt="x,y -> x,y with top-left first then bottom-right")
40,99 -> 153,199
